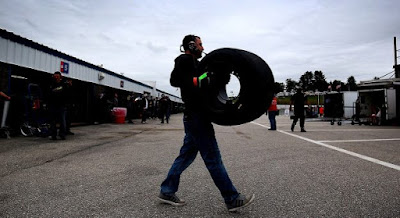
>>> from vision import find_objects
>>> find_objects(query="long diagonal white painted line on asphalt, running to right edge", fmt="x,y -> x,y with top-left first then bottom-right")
251,121 -> 400,171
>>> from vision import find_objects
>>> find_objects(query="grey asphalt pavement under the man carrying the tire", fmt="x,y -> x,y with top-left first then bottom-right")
0,114 -> 400,217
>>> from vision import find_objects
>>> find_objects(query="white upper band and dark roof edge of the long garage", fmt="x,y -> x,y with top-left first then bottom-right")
0,29 -> 182,102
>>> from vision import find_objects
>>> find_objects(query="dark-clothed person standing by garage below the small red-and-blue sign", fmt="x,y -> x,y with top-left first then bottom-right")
49,71 -> 67,140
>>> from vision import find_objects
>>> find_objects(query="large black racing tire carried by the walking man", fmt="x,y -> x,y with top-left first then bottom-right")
199,48 -> 274,126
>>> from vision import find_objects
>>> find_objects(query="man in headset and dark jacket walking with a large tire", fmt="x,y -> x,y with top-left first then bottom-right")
158,35 -> 254,211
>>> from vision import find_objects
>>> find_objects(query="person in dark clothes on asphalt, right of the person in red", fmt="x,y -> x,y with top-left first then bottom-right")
289,88 -> 308,132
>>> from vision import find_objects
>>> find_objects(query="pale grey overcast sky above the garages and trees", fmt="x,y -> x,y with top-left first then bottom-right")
0,0 -> 400,95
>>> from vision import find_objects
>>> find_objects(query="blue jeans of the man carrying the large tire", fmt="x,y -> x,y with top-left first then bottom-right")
161,113 -> 239,203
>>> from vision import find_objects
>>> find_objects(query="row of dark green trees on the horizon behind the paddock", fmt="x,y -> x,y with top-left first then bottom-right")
274,71 -> 357,93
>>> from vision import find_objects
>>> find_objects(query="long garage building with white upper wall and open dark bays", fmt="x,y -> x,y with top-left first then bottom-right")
0,29 -> 183,129
